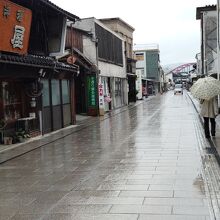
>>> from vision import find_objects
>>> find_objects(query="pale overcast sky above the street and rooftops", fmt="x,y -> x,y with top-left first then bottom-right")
51,0 -> 217,65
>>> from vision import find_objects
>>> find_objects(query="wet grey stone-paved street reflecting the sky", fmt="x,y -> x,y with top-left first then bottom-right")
0,92 -> 220,220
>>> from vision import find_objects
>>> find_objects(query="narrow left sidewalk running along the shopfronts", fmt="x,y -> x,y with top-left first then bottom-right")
0,96 -> 154,164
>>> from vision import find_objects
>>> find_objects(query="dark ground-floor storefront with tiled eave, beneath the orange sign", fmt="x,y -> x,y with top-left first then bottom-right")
0,55 -> 78,143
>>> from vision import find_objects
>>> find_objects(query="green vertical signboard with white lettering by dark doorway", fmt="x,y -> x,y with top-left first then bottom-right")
87,75 -> 97,115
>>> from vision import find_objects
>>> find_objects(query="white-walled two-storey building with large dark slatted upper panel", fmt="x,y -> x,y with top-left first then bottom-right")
74,17 -> 128,114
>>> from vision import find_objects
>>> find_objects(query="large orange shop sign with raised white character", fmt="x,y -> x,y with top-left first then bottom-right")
0,0 -> 32,54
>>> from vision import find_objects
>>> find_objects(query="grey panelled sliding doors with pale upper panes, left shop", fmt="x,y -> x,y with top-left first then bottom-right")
42,79 -> 73,133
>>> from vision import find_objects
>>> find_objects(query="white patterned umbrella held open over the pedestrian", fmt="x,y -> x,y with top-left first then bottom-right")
190,77 -> 220,100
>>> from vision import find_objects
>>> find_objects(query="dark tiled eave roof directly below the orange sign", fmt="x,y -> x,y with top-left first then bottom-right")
0,54 -> 78,72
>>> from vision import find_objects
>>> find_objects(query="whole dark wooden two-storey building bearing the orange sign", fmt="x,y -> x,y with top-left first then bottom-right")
0,0 -> 79,142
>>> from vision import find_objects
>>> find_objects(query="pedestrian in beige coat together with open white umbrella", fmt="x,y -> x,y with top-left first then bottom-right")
190,76 -> 220,138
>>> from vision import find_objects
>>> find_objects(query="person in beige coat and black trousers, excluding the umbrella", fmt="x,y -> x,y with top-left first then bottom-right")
200,97 -> 218,138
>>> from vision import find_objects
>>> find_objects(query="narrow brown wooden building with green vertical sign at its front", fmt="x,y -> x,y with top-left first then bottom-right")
59,25 -> 99,116
